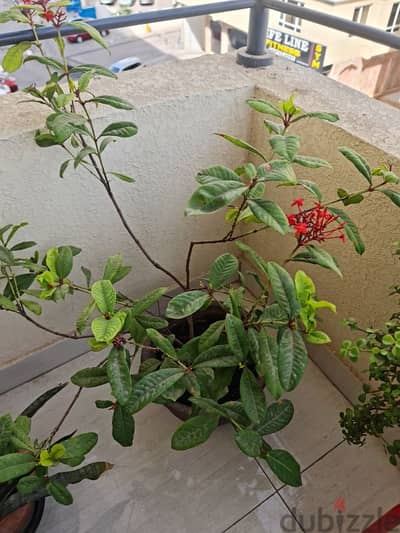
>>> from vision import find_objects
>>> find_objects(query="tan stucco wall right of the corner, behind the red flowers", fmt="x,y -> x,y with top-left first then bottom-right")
244,57 -> 400,377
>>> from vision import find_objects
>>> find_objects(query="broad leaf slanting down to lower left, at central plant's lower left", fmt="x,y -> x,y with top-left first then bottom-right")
126,368 -> 185,414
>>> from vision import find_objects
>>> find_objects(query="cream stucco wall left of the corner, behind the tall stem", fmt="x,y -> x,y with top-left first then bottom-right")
0,57 -> 253,365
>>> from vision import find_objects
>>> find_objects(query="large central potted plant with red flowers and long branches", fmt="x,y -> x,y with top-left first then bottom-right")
0,0 -> 400,524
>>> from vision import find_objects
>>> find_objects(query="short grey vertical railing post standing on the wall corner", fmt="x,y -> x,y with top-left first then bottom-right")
236,0 -> 273,68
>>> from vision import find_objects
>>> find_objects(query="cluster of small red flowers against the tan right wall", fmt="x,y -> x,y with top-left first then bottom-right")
287,198 -> 346,246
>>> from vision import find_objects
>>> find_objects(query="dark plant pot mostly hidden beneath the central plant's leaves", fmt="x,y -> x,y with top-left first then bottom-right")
141,303 -> 265,425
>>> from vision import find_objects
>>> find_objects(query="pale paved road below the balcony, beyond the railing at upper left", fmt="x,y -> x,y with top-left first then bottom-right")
0,0 -> 182,88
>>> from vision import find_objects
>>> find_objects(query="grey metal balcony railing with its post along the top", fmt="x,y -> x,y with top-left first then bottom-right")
0,0 -> 400,68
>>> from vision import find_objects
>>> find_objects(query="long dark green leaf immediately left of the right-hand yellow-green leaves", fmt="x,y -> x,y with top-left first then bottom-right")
267,261 -> 300,319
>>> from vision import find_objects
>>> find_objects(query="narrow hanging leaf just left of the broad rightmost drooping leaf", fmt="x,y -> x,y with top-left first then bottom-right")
257,329 -> 282,400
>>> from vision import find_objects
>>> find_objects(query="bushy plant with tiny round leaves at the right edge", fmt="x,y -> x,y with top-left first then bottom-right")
340,243 -> 400,465
